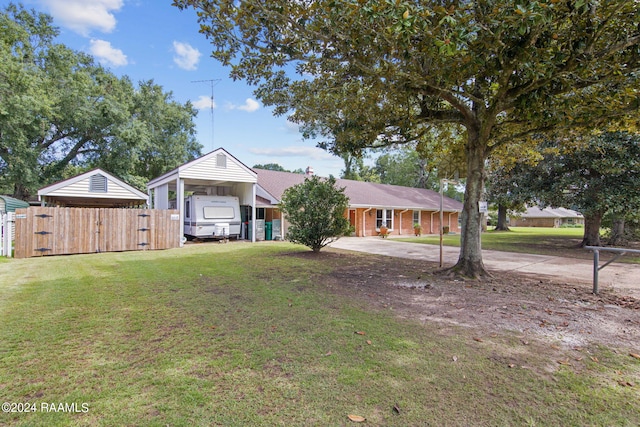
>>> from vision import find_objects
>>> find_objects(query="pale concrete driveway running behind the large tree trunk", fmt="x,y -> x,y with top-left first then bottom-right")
331,237 -> 640,297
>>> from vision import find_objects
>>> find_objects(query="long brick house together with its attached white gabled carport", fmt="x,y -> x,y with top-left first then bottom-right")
147,148 -> 462,241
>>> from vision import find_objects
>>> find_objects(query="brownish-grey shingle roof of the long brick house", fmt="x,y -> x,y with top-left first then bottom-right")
254,169 -> 462,211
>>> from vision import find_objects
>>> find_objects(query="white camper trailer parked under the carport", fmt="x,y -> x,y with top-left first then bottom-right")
184,196 -> 241,239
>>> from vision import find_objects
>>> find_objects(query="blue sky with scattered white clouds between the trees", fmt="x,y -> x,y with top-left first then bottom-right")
5,0 -> 344,176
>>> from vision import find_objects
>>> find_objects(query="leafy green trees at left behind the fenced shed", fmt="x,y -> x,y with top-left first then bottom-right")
0,4 -> 201,199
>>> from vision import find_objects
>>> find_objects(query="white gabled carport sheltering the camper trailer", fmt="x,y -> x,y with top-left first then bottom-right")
147,148 -> 258,241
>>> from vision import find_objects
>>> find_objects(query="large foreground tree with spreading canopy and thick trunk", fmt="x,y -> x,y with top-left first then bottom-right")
174,0 -> 640,276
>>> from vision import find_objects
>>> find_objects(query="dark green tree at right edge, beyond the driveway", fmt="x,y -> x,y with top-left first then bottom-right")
510,132 -> 640,246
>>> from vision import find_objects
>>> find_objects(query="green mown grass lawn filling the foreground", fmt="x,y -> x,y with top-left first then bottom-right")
0,242 -> 640,426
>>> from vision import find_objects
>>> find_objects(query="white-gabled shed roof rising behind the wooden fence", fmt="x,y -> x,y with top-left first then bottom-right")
38,169 -> 149,208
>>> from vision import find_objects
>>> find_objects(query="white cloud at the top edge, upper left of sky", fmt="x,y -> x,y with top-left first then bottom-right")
39,0 -> 123,37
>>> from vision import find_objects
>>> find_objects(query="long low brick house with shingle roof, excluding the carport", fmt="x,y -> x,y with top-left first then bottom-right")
255,169 -> 462,241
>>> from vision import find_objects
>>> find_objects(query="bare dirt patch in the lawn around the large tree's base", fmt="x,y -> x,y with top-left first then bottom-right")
292,249 -> 640,353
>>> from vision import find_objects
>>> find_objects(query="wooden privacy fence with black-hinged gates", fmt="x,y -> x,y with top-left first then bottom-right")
14,207 -> 182,258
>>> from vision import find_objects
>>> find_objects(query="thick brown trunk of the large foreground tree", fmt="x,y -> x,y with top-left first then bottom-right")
450,129 -> 488,278
